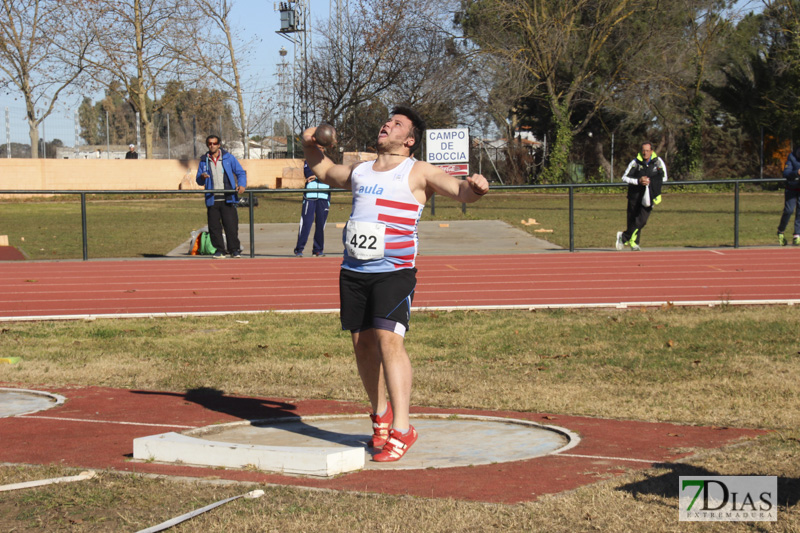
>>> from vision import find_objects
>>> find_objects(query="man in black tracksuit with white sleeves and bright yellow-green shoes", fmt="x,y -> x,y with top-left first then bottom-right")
616,142 -> 667,250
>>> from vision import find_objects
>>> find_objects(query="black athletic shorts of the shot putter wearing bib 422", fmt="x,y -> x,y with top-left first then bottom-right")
339,268 -> 417,335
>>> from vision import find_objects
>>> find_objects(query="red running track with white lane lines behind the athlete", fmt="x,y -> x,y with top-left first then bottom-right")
0,247 -> 800,320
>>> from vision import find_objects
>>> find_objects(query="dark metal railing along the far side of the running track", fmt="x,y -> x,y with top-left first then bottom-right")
0,179 -> 785,261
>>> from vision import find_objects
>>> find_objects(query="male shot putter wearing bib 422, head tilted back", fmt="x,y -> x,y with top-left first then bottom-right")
303,106 -> 489,462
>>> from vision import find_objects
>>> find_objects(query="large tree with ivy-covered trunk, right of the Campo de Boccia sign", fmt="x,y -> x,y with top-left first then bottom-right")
461,0 -> 657,181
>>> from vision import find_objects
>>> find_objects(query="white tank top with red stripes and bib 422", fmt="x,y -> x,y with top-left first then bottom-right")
342,158 -> 425,272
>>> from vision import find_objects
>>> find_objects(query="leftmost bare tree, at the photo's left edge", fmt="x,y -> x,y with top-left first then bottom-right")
0,0 -> 91,158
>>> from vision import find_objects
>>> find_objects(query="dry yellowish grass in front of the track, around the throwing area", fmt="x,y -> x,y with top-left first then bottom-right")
0,306 -> 800,532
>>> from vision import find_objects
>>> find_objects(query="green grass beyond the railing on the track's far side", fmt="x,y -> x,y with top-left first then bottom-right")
0,189 -> 783,259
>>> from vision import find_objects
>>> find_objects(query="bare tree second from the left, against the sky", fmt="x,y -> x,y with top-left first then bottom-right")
83,0 -> 194,158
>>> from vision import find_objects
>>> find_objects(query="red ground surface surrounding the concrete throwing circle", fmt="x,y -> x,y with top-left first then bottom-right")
0,387 -> 765,502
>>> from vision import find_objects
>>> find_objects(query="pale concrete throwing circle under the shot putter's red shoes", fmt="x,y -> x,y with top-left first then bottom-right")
189,414 -> 580,470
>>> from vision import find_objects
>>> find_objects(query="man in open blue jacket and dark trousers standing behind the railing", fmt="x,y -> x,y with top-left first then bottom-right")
196,135 -> 247,259
